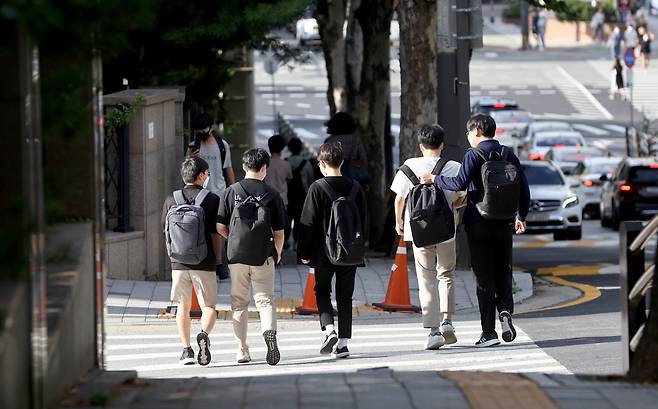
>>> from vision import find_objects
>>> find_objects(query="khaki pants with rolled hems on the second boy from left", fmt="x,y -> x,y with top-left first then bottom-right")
228,257 -> 276,345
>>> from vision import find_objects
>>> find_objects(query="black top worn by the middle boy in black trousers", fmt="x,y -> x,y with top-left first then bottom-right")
297,176 -> 369,267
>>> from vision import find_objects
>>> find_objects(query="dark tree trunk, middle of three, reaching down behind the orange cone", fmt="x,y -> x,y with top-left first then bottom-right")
348,0 -> 393,247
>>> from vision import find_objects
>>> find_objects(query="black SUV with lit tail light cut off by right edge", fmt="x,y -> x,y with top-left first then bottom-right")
600,158 -> 658,230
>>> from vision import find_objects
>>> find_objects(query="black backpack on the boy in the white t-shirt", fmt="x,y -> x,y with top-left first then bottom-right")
400,158 -> 455,247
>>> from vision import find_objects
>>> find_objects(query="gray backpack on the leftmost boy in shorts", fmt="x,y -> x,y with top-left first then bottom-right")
165,189 -> 210,265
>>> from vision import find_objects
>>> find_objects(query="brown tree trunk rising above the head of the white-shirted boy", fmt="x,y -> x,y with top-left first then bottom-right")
397,0 -> 437,163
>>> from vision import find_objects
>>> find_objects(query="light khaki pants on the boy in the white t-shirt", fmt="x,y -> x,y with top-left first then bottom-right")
413,240 -> 457,328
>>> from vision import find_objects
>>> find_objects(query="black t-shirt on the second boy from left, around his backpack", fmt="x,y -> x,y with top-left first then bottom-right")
217,179 -> 288,256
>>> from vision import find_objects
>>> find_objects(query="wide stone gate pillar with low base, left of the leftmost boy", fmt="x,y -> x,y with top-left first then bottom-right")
104,89 -> 182,280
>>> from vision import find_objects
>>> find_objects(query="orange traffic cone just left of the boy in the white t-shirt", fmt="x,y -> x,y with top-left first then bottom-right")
372,237 -> 420,312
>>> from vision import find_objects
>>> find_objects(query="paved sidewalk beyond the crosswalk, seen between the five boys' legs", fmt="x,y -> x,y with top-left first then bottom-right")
105,258 -> 532,324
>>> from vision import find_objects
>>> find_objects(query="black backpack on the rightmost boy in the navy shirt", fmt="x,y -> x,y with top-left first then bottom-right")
473,146 -> 521,220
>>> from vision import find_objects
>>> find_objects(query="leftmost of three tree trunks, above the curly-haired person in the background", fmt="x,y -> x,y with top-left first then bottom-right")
316,0 -> 349,115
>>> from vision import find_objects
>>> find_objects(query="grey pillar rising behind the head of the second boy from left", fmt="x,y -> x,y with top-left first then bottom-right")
223,47 -> 256,180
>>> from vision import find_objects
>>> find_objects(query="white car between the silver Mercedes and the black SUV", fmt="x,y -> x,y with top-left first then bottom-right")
572,157 -> 622,217
